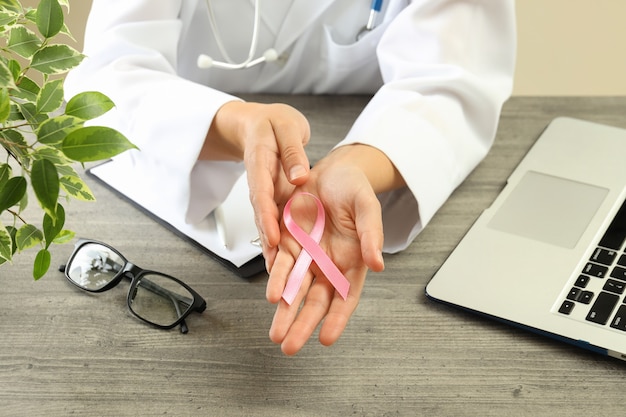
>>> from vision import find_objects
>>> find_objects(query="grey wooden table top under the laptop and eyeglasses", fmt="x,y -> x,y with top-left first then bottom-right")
0,96 -> 626,417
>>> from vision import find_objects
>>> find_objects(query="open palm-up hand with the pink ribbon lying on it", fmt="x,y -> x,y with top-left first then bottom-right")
266,145 -> 403,355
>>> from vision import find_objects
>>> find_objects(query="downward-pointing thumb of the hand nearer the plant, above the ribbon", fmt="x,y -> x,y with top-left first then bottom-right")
272,112 -> 311,185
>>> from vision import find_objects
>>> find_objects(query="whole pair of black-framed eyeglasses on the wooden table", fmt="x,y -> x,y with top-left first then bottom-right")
59,239 -> 206,333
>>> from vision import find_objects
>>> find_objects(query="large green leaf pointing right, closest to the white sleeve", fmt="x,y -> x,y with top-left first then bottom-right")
62,126 -> 137,162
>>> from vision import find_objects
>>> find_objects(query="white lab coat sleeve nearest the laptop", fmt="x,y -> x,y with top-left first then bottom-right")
339,0 -> 516,252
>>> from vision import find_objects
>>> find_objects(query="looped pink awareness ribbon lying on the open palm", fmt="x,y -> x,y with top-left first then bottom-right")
283,193 -> 350,305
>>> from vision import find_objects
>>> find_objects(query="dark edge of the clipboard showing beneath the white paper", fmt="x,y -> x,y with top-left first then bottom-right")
87,160 -> 265,279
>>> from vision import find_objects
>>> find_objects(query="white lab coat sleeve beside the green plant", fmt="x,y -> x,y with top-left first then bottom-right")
65,0 -> 243,223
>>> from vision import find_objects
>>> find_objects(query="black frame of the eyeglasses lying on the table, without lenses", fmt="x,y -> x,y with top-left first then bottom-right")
59,238 -> 206,334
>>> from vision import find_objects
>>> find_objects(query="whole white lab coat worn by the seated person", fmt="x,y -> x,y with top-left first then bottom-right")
65,0 -> 515,252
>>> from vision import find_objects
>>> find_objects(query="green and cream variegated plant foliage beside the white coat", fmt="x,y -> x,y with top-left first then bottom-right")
0,0 -> 134,279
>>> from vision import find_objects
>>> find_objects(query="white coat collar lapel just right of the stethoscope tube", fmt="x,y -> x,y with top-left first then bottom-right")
274,0 -> 334,53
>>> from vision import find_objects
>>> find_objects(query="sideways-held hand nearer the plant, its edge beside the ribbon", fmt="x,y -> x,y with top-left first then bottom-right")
200,101 -> 310,262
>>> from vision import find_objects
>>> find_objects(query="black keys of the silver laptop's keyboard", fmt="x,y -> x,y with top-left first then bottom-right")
558,195 -> 626,332
